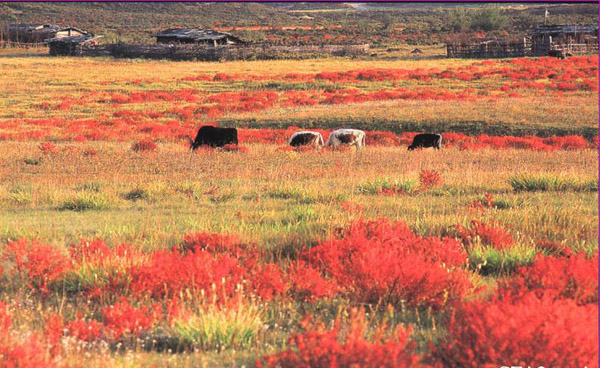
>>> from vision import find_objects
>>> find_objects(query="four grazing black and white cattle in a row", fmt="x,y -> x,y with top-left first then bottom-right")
190,126 -> 442,151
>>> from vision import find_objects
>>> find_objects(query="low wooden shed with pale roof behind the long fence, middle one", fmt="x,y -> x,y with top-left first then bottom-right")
154,28 -> 245,47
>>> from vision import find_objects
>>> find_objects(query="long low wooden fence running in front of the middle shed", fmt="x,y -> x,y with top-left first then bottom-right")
78,43 -> 370,61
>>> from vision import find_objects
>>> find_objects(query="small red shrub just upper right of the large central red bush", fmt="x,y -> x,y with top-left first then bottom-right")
456,220 -> 515,249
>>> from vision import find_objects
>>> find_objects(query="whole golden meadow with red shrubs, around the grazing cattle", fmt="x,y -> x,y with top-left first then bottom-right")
0,50 -> 598,368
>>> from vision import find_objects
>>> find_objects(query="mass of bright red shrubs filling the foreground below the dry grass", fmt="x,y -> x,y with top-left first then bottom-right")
0,214 -> 598,367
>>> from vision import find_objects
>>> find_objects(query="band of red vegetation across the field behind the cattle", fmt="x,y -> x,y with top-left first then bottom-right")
0,57 -> 598,150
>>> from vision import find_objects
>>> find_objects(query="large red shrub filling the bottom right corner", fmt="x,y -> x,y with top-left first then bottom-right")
432,293 -> 598,368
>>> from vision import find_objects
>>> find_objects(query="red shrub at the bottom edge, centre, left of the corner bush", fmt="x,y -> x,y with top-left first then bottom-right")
256,311 -> 426,368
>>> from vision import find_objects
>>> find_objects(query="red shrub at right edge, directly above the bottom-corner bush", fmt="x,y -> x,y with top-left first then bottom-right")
502,253 -> 598,304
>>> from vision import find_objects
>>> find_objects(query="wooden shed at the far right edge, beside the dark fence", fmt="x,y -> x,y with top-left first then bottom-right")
530,24 -> 598,56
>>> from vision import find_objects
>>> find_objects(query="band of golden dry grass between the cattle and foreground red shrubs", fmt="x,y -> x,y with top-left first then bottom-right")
0,143 -> 597,248
